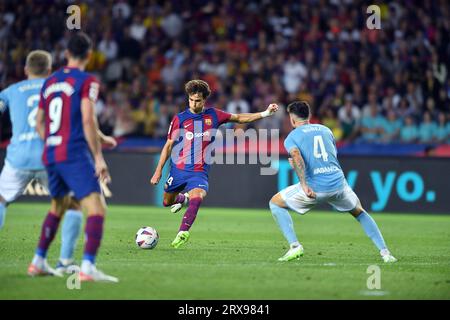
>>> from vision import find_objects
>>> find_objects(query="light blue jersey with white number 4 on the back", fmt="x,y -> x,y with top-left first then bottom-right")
284,124 -> 345,192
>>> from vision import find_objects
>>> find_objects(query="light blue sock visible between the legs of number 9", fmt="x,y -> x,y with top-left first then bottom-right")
59,210 -> 83,260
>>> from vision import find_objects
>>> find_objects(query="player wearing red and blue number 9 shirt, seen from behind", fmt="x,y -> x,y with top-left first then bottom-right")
28,32 -> 118,282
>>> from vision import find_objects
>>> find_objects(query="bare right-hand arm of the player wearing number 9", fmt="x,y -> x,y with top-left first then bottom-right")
81,98 -> 111,182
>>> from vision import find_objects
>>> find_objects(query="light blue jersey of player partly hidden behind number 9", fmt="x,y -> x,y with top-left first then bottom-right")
0,79 -> 45,170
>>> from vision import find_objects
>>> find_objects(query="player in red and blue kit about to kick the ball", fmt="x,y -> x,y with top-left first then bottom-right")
150,80 -> 278,248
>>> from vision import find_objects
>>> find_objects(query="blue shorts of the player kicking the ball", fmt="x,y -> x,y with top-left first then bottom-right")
164,168 -> 209,193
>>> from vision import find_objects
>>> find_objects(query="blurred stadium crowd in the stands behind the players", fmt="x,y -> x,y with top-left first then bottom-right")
0,0 -> 450,143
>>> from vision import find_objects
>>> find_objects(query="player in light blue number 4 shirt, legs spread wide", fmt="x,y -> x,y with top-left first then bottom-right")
269,101 -> 397,263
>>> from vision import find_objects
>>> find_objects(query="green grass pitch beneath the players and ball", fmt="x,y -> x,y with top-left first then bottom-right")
0,203 -> 450,300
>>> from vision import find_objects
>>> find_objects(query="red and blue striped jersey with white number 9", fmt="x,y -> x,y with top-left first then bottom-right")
39,67 -> 99,165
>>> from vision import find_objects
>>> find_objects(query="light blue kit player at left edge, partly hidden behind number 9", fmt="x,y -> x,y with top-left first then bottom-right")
0,50 -> 113,273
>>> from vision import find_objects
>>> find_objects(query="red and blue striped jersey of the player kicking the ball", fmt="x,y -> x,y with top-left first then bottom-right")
167,108 -> 231,172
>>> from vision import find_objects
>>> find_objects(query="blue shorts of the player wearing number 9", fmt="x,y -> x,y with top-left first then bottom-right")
46,158 -> 101,200
